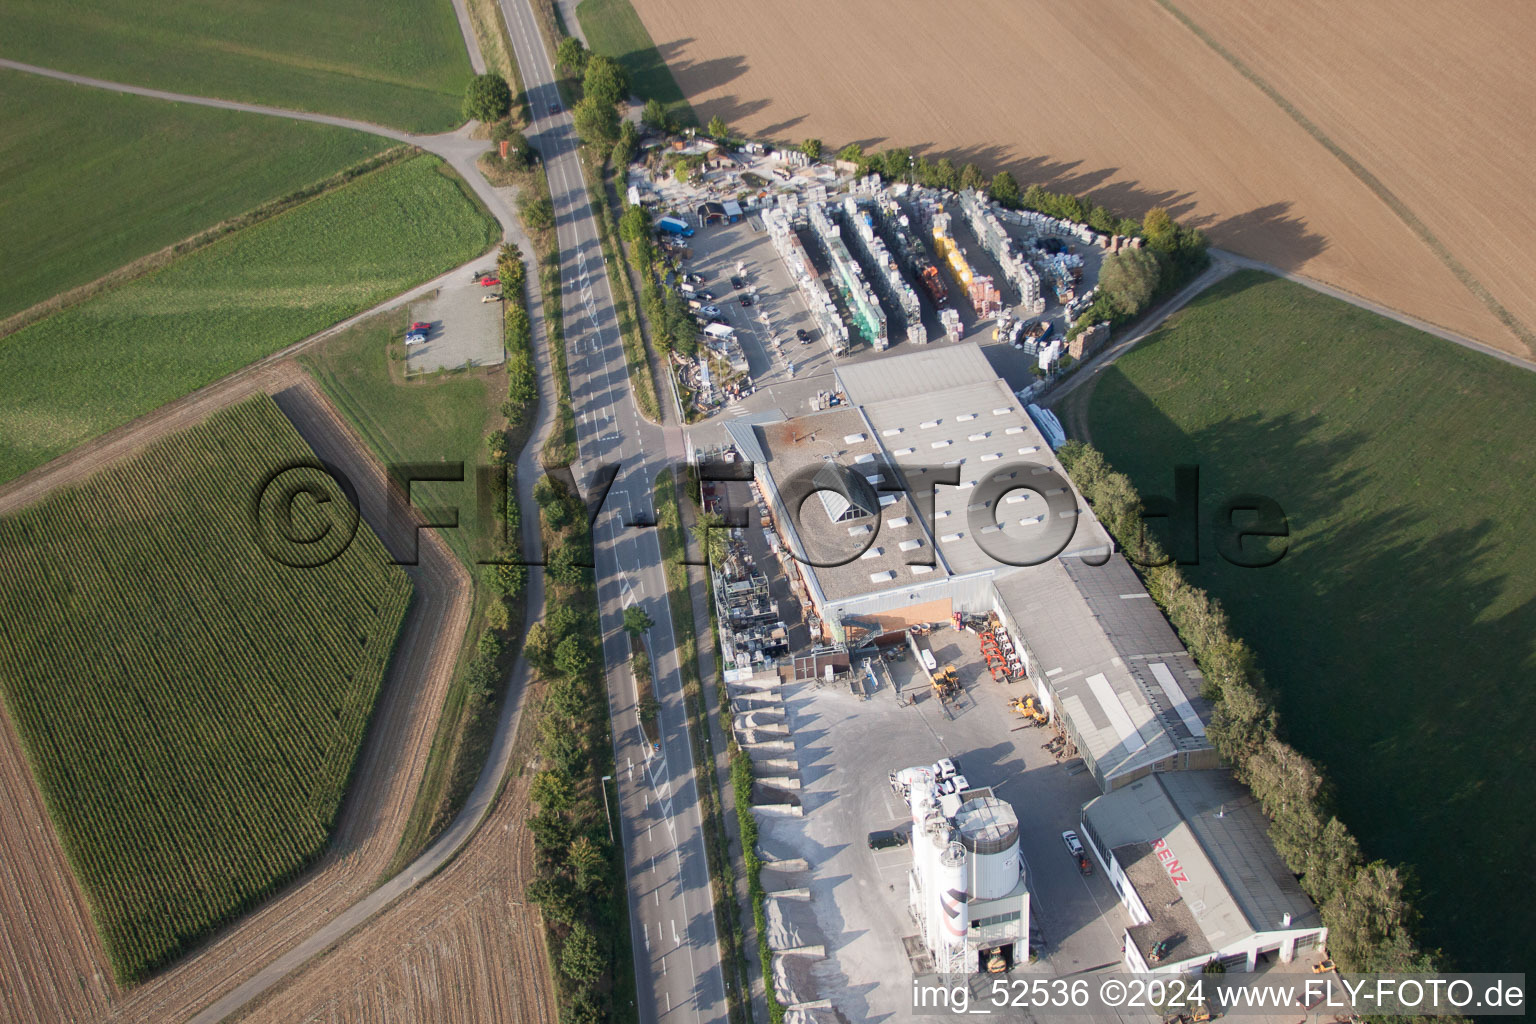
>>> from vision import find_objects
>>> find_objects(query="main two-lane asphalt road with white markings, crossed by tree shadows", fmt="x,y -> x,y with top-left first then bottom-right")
501,0 -> 727,1024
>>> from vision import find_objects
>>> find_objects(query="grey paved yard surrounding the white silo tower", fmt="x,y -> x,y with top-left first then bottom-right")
760,628 -> 1143,1022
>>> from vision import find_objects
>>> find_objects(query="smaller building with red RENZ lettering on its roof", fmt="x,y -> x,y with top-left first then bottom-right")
1083,771 -> 1327,973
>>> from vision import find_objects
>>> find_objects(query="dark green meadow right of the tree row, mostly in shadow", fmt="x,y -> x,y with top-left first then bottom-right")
1091,303 -> 1536,970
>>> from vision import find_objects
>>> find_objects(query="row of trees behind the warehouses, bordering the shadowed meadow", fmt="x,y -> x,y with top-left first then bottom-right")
1057,441 -> 1439,972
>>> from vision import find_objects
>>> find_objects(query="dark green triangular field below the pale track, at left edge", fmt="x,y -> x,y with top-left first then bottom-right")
0,69 -> 387,318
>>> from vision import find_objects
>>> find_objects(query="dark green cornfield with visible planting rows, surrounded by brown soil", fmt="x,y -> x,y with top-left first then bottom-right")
0,396 -> 410,981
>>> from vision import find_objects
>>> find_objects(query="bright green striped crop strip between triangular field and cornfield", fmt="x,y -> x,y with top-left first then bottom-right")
0,157 -> 499,481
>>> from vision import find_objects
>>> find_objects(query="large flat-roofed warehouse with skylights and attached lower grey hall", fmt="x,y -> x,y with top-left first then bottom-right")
727,344 -> 1218,791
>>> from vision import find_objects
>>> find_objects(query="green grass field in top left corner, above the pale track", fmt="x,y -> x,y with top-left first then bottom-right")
0,0 -> 472,132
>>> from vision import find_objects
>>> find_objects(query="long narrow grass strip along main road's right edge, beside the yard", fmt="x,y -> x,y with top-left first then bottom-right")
653,470 -> 752,1022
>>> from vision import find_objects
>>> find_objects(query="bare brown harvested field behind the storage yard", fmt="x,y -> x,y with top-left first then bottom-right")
633,0 -> 1536,358
